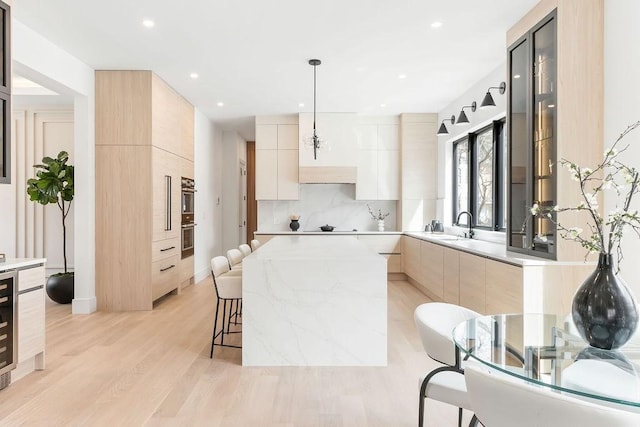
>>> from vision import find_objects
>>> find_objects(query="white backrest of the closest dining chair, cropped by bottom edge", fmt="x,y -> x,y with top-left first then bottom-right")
464,363 -> 640,427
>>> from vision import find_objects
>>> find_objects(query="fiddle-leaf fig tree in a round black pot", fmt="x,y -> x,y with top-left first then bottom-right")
27,151 -> 73,304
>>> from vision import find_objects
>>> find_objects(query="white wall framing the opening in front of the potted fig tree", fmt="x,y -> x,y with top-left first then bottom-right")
11,19 -> 96,313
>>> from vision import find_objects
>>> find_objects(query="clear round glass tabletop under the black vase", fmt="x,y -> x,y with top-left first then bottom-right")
453,314 -> 640,411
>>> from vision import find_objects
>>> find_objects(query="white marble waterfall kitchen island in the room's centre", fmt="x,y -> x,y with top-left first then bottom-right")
242,235 -> 387,366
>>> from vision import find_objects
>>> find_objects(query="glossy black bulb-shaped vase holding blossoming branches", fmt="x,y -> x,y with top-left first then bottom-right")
571,254 -> 638,350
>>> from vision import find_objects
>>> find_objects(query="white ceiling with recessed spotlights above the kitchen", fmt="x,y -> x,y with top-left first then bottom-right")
13,0 -> 538,139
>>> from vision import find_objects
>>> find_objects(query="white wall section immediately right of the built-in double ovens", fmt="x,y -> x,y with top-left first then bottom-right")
194,108 -> 222,283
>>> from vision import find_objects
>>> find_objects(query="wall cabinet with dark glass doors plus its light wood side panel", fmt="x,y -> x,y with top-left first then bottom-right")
507,0 -> 604,261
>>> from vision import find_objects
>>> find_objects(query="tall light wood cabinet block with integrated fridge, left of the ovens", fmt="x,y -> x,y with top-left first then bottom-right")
96,71 -> 193,311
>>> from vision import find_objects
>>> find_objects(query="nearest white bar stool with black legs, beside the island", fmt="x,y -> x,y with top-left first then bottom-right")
209,256 -> 242,358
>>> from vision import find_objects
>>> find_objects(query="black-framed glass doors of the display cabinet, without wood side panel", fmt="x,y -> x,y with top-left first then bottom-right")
507,11 -> 557,259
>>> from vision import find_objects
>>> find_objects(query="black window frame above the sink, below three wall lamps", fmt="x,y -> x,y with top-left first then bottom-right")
451,118 -> 506,232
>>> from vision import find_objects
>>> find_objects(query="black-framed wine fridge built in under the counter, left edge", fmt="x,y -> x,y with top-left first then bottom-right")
0,271 -> 18,389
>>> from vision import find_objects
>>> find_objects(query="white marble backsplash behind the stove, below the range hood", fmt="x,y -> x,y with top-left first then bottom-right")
258,184 -> 398,232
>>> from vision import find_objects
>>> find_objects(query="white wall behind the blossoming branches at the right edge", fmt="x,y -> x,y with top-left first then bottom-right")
604,0 -> 640,298
